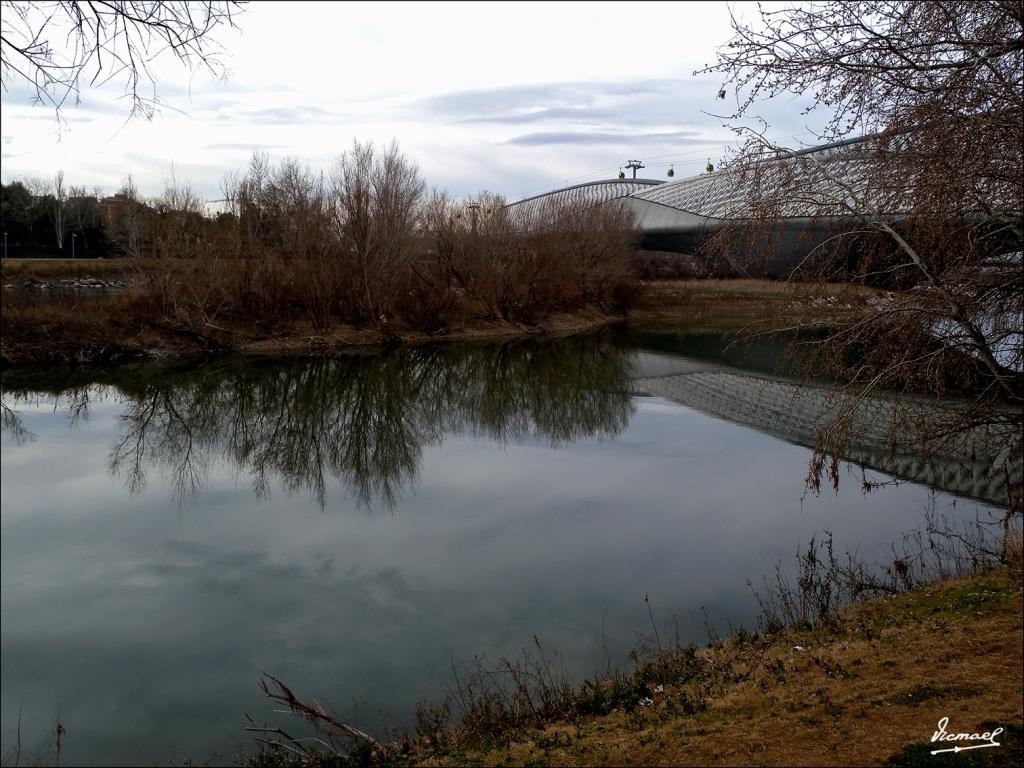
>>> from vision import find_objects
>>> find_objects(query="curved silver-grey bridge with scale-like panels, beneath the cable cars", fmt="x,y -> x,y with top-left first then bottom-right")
508,138 -> 881,273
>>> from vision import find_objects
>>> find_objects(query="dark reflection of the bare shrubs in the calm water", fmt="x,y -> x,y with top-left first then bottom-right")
5,339 -> 632,506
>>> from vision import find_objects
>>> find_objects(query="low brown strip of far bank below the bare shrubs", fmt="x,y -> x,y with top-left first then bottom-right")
0,259 -> 879,365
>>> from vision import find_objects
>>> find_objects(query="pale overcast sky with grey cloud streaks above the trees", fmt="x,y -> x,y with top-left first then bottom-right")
0,2 -> 814,200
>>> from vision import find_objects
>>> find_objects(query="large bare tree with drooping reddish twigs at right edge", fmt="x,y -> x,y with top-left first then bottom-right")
703,0 -> 1024,508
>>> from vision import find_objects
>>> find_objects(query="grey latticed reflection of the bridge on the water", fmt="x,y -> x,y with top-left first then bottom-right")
630,351 -> 1022,506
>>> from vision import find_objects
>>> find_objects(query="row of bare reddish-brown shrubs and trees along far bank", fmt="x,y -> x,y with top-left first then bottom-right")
3,141 -> 639,333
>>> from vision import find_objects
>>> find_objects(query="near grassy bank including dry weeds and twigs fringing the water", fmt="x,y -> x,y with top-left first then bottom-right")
232,520 -> 1024,767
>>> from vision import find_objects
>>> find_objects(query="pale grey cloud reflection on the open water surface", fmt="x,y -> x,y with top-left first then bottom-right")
0,348 -> 995,763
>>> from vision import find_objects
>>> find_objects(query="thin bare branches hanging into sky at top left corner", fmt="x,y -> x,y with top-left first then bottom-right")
0,0 -> 244,118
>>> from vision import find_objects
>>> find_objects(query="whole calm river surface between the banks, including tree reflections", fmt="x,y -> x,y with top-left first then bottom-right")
0,331 -> 1001,764
